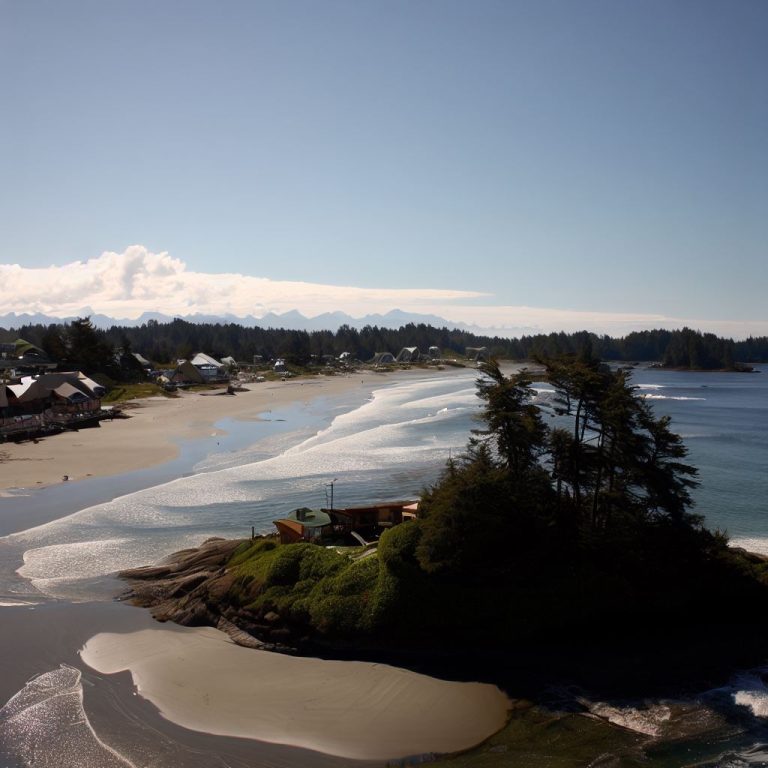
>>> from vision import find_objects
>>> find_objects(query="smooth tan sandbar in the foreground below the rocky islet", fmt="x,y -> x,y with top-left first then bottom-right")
81,628 -> 509,760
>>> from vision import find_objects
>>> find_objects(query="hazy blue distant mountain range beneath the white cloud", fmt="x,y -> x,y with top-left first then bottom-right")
0,307 -> 496,333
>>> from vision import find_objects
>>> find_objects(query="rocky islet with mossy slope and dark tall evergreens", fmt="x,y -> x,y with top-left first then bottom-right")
122,353 -> 768,704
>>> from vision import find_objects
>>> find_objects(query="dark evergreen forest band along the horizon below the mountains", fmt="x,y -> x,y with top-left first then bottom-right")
0,318 -> 768,370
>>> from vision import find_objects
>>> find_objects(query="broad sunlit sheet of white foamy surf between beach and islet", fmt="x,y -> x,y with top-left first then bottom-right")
0,374 -> 477,599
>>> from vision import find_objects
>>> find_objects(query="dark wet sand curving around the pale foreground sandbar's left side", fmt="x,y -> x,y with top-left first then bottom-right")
0,603 -> 381,768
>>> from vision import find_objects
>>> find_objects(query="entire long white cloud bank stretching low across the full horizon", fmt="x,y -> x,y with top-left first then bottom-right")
0,245 -> 768,338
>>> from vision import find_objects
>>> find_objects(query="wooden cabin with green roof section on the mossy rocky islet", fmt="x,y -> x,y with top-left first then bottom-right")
274,500 -> 419,544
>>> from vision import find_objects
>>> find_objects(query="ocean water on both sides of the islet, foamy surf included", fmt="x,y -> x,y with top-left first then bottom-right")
0,366 -> 768,766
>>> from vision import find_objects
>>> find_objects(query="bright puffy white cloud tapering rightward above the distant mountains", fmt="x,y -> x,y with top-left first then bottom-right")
0,245 -> 483,319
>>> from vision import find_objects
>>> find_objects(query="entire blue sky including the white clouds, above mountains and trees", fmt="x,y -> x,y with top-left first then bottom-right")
0,0 -> 768,338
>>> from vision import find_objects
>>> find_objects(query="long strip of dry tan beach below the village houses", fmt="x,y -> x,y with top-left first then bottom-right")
0,374 -> 366,495
